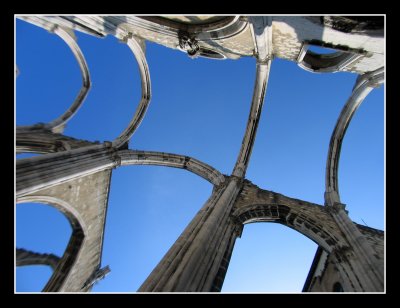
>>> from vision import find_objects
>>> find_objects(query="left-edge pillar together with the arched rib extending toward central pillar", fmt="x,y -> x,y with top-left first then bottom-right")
16,142 -> 225,198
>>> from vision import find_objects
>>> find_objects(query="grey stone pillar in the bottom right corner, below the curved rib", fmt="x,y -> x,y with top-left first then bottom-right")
329,203 -> 384,292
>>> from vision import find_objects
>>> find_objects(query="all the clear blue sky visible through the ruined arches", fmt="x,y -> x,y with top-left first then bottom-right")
16,20 -> 384,292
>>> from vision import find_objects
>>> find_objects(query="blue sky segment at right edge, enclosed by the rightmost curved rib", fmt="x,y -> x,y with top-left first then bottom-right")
337,85 -> 385,230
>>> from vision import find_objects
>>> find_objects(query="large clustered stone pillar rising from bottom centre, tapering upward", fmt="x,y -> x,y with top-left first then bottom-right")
138,176 -> 242,292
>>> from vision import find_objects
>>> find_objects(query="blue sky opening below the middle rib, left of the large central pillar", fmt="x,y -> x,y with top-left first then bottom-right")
92,166 -> 212,292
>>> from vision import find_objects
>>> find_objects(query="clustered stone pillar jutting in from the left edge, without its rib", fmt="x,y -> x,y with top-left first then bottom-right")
16,142 -> 119,198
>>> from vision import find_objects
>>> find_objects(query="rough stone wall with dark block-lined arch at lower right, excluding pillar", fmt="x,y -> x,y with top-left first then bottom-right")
232,180 -> 384,292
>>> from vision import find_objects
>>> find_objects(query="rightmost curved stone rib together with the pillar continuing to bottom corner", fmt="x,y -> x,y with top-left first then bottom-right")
325,67 -> 384,292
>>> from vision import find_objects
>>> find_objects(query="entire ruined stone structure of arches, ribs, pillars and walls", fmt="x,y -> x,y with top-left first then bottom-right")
16,15 -> 385,292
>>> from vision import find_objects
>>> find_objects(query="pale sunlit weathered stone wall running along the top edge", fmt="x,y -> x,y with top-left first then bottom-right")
20,15 -> 384,74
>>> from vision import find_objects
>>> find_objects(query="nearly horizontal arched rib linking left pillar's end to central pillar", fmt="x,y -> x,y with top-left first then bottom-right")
118,150 -> 225,186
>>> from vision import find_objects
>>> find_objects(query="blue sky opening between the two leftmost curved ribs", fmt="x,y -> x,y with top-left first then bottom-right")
61,32 -> 142,142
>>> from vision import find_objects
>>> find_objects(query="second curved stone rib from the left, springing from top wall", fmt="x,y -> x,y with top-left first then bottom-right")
112,37 -> 151,148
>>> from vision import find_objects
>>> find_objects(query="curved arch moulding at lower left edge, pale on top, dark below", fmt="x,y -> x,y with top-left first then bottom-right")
17,196 -> 87,292
